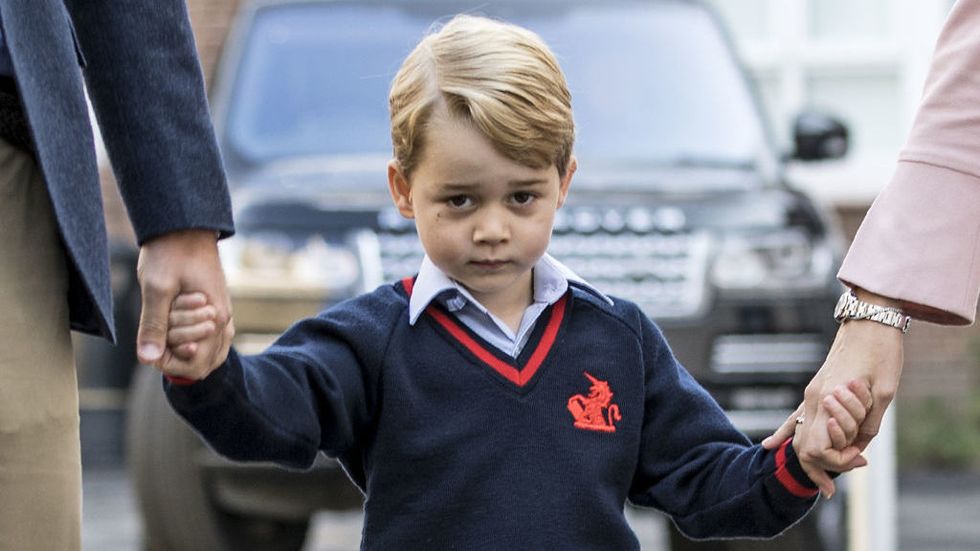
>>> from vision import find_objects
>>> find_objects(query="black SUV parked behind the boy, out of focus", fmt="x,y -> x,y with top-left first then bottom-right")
129,0 -> 847,550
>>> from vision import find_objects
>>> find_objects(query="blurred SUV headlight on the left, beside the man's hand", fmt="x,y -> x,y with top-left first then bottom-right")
220,232 -> 361,299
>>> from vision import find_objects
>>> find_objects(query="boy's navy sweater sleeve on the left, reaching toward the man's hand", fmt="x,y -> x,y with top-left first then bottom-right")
164,292 -> 404,468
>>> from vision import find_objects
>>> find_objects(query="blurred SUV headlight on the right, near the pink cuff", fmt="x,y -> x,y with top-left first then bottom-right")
712,230 -> 833,291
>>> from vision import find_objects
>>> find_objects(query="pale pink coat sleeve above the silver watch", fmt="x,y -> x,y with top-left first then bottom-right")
838,0 -> 980,325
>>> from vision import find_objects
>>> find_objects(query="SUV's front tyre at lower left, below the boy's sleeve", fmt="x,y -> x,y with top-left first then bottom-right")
127,367 -> 308,551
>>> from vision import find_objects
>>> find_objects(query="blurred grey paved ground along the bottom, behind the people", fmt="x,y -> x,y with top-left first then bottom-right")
82,468 -> 980,551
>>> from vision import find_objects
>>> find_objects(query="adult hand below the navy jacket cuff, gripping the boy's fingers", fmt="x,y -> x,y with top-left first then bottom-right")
136,230 -> 234,379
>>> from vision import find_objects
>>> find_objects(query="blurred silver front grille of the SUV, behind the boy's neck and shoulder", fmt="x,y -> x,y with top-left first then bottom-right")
372,207 -> 710,319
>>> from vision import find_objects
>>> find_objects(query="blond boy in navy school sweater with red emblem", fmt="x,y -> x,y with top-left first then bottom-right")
166,16 -> 870,550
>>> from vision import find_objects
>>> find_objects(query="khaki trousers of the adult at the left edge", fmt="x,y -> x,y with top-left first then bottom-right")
0,141 -> 82,551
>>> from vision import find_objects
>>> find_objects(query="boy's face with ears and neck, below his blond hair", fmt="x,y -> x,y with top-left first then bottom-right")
388,113 -> 575,309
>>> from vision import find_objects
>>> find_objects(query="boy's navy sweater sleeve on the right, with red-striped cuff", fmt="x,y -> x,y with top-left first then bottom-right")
630,313 -> 817,539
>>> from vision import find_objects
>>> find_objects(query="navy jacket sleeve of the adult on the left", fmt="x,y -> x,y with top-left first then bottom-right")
66,0 -> 234,244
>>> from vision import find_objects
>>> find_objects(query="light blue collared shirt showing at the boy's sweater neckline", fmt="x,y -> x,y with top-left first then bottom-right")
408,254 -> 612,358
